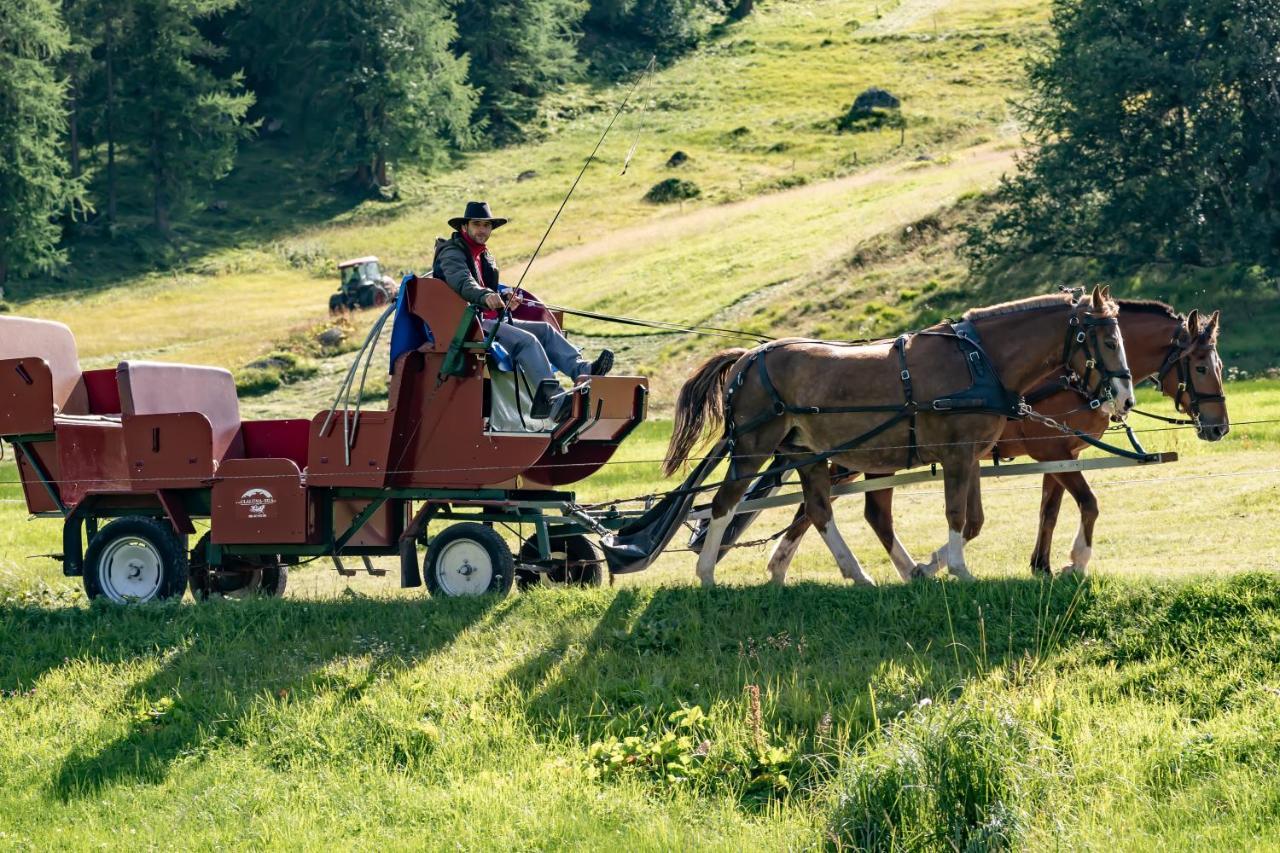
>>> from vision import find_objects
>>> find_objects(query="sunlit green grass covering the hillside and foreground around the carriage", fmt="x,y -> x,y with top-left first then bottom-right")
0,0 -> 1280,849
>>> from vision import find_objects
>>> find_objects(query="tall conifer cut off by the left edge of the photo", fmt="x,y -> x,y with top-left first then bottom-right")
0,0 -> 81,288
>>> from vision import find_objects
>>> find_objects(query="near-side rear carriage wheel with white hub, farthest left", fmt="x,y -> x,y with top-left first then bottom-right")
84,515 -> 187,605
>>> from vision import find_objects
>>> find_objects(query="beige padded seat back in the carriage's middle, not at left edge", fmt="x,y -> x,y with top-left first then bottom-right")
115,361 -> 244,461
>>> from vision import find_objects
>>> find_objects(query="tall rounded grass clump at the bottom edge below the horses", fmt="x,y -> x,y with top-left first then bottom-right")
828,703 -> 1056,850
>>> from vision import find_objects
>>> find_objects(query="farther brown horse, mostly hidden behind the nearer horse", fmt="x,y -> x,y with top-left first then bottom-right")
769,300 -> 1230,584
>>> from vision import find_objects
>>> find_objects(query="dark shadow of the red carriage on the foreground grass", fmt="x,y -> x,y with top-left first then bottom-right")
0,597 -> 498,800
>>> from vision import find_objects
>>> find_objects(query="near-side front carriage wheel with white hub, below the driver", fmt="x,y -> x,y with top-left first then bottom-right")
422,521 -> 516,597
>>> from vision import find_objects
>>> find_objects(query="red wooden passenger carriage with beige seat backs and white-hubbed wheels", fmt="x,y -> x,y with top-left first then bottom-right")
0,277 -> 648,602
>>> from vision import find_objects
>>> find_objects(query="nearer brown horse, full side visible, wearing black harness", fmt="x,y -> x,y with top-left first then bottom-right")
663,288 -> 1133,587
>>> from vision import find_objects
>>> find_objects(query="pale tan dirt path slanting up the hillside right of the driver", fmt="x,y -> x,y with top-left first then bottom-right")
517,143 -> 1014,275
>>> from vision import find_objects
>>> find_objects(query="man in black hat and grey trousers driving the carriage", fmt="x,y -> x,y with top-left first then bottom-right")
431,201 -> 613,419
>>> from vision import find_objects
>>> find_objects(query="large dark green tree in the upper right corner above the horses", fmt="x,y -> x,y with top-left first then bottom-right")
970,0 -> 1280,269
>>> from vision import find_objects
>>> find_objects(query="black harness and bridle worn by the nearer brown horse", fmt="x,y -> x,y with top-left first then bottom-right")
724,308 -> 1129,476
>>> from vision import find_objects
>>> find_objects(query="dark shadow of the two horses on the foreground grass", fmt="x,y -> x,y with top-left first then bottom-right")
496,579 -> 1089,740
